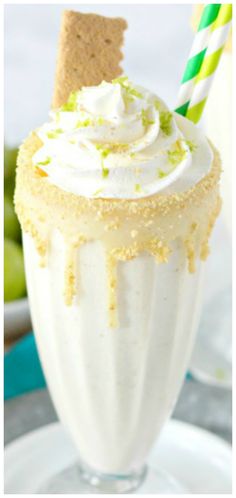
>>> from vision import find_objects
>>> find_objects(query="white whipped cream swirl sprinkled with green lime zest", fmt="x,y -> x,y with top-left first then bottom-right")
33,77 -> 212,199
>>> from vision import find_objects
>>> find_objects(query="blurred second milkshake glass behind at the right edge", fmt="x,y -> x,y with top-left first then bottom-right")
191,5 -> 232,388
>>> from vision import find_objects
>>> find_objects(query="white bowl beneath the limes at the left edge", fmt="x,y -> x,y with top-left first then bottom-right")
4,297 -> 31,338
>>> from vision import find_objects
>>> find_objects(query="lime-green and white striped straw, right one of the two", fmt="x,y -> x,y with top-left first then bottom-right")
175,4 -> 232,123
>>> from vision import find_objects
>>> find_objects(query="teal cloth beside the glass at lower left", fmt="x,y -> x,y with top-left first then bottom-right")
4,333 -> 46,400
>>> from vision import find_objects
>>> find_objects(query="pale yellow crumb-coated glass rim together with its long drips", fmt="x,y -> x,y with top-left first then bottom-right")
14,132 -> 221,328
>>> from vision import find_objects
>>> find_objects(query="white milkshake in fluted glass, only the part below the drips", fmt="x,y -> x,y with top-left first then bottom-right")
24,232 -> 203,473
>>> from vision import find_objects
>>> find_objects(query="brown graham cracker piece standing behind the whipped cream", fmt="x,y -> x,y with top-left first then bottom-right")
52,10 -> 127,108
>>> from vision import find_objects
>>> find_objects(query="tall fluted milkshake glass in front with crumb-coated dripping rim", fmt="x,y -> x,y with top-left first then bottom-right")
15,130 -> 220,493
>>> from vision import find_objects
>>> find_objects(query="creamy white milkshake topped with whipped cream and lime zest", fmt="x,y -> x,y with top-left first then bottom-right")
15,77 -> 220,488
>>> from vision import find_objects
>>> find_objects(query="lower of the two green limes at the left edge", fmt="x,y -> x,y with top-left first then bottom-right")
4,239 -> 26,301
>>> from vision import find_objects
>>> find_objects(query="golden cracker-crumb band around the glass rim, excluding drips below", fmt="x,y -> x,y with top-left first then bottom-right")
16,131 -> 221,218
